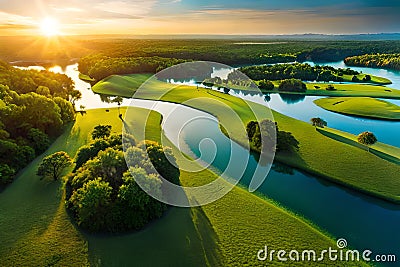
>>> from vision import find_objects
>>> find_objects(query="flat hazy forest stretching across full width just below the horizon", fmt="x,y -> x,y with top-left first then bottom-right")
0,36 -> 400,69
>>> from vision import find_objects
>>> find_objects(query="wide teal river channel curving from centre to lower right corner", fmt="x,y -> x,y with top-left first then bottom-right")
129,100 -> 400,266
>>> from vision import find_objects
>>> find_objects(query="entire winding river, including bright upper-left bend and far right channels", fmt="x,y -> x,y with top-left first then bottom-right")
16,62 -> 400,266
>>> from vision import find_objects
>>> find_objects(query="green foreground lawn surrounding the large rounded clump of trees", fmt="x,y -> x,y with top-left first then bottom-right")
0,109 -> 360,266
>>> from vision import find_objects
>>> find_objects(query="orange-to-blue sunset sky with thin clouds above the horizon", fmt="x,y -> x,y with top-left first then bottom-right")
0,0 -> 400,36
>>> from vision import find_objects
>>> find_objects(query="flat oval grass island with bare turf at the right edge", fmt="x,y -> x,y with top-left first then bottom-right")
314,97 -> 400,120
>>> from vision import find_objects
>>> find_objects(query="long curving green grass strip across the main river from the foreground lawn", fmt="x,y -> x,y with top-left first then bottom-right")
90,75 -> 400,203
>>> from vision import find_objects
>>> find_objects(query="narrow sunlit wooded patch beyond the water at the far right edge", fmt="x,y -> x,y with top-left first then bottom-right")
344,54 -> 400,70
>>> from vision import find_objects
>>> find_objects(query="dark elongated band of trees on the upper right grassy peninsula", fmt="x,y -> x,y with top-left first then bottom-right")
240,63 -> 359,82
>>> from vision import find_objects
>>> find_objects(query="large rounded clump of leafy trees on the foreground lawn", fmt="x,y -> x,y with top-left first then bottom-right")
66,125 -> 179,232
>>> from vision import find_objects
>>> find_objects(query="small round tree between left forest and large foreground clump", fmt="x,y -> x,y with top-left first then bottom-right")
36,151 -> 72,181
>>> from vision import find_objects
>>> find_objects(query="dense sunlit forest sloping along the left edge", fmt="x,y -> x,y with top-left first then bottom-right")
0,61 -> 79,185
